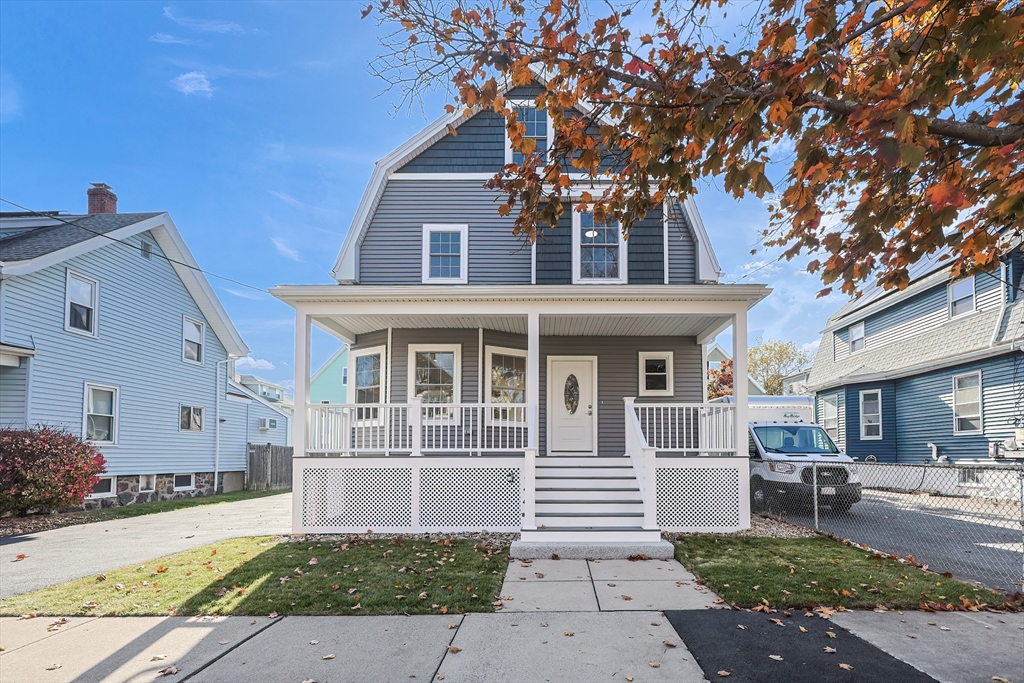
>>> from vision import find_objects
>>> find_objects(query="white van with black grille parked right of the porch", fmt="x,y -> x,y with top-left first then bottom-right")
748,421 -> 860,512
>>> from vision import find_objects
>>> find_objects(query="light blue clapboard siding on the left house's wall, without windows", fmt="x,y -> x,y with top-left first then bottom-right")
4,229 -> 233,474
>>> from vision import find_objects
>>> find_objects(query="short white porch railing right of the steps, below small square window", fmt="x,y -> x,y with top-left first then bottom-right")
633,403 -> 738,456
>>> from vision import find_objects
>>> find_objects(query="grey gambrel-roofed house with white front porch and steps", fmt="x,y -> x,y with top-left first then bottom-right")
273,81 -> 769,557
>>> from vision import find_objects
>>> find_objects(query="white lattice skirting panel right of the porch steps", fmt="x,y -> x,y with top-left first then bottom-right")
656,458 -> 751,533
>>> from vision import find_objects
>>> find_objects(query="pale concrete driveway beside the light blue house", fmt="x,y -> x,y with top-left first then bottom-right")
0,494 -> 292,598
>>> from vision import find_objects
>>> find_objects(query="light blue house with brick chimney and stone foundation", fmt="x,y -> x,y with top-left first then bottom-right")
0,184 -> 288,506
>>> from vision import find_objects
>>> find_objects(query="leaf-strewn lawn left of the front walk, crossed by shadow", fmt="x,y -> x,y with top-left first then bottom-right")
0,538 -> 506,616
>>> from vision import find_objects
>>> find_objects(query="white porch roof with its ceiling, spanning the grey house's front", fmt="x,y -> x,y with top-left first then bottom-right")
271,285 -> 771,343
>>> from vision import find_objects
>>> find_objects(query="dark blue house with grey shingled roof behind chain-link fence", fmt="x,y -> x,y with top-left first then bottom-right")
808,244 -> 1024,462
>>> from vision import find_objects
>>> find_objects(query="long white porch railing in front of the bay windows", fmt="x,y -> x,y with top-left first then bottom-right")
305,399 -> 537,457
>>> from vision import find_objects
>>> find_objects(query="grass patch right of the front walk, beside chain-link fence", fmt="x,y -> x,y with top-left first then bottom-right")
676,536 -> 1004,609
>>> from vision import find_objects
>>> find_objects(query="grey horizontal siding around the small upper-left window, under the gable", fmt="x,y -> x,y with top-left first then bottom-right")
359,180 -> 530,285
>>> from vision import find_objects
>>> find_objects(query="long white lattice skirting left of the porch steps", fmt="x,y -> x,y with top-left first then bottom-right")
293,457 -> 523,533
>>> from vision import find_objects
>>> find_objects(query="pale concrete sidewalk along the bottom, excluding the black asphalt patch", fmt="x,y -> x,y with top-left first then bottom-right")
0,610 -> 1024,683
